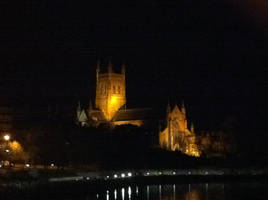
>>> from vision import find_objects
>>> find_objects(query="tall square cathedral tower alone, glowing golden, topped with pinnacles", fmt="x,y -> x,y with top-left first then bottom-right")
95,62 -> 126,121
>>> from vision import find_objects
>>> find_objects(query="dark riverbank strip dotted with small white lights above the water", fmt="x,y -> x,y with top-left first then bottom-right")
0,168 -> 268,190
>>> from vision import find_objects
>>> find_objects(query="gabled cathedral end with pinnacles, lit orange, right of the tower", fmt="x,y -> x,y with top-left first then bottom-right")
159,105 -> 200,157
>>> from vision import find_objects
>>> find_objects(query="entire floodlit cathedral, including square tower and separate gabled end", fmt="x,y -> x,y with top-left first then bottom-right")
76,62 -> 200,156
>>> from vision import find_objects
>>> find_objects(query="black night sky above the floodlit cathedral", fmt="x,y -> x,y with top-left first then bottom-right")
0,0 -> 268,131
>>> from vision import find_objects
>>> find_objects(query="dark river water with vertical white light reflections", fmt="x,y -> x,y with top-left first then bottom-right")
0,181 -> 268,200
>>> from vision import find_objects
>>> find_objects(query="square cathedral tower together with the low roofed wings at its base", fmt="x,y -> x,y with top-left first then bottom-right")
76,62 -> 144,126
